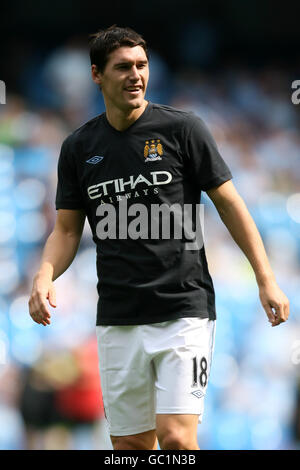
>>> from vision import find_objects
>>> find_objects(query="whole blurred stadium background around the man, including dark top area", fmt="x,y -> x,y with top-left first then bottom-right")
0,0 -> 300,449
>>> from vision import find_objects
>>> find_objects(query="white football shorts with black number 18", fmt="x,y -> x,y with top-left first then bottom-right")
96,318 -> 216,436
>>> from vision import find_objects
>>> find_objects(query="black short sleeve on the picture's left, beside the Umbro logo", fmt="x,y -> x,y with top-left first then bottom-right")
55,136 -> 84,209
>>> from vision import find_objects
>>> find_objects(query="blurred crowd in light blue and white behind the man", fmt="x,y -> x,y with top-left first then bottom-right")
0,41 -> 300,449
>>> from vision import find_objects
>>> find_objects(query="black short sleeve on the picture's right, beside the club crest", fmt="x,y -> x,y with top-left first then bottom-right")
186,114 -> 232,191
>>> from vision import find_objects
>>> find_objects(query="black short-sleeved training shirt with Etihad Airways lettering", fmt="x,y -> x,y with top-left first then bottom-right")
56,102 -> 232,325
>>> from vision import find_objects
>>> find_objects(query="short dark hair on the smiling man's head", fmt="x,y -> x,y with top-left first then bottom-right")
90,25 -> 149,72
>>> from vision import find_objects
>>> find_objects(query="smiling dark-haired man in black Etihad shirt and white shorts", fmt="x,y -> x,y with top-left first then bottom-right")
29,27 -> 289,450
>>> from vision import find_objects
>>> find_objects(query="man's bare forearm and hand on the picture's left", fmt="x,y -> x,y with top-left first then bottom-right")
29,209 -> 85,326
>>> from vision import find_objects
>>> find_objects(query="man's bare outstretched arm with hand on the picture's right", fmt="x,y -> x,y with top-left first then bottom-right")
207,181 -> 289,326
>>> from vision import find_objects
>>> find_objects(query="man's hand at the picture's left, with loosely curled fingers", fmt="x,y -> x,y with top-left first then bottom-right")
28,275 -> 56,326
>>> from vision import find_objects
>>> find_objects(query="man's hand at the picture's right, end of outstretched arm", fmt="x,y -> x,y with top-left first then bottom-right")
259,281 -> 290,326
